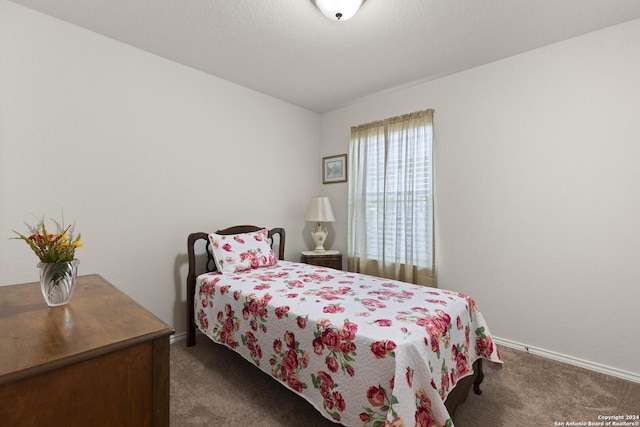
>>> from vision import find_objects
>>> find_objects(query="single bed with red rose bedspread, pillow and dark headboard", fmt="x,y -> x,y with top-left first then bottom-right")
187,225 -> 502,426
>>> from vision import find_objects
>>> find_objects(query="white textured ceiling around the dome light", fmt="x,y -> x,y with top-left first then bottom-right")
13,0 -> 640,113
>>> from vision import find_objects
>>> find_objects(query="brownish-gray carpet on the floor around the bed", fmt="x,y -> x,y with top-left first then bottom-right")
171,336 -> 640,427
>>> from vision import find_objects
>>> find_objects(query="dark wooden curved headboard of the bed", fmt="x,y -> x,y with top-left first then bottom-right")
187,225 -> 285,347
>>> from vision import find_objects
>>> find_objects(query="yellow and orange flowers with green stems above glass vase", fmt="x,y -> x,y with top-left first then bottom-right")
13,219 -> 82,263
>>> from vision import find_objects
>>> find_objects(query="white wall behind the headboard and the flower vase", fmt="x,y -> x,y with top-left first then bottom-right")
0,0 -> 320,332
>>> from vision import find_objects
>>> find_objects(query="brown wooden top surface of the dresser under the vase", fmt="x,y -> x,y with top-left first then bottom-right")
0,275 -> 174,384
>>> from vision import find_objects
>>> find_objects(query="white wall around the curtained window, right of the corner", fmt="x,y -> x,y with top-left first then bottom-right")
321,20 -> 640,378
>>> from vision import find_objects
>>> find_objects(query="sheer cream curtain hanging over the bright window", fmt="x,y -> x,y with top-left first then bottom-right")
348,110 -> 435,286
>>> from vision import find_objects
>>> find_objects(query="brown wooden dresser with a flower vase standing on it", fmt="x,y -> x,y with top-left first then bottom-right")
0,275 -> 174,427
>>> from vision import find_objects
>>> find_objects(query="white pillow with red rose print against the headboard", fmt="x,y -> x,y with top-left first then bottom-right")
209,229 -> 278,273
